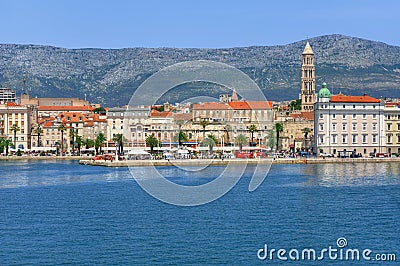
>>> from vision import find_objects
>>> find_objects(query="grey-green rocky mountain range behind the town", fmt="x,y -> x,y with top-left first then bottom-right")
0,34 -> 400,107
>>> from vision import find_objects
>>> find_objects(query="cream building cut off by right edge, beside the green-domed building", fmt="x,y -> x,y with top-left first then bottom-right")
384,101 -> 400,154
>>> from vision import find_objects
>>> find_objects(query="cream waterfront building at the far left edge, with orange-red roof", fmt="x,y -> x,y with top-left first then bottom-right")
0,102 -> 32,151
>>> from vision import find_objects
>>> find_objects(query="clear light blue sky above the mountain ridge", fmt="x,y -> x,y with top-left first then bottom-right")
0,0 -> 400,49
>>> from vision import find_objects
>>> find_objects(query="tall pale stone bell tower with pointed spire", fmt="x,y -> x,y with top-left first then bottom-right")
301,42 -> 316,112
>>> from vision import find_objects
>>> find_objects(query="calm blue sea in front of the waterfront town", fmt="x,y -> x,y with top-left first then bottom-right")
0,161 -> 400,265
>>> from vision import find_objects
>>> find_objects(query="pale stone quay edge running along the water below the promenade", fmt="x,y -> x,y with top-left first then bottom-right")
79,157 -> 400,167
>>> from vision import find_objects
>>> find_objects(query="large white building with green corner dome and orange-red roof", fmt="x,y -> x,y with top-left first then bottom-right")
314,83 -> 386,156
